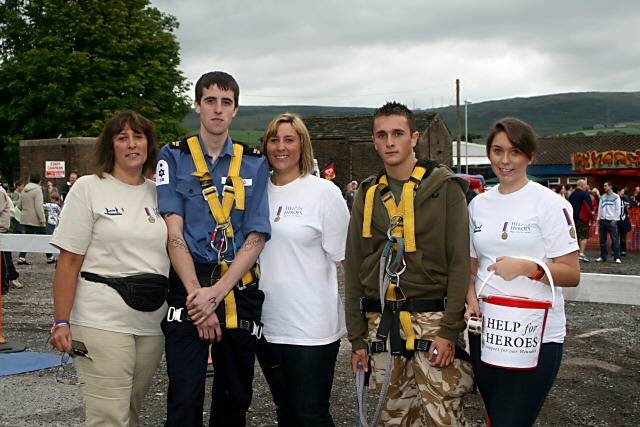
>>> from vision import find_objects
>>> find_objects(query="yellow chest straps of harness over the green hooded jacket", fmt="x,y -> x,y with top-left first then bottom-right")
362,162 -> 428,252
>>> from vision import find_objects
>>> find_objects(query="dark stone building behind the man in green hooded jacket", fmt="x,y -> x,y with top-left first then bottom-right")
304,113 -> 452,188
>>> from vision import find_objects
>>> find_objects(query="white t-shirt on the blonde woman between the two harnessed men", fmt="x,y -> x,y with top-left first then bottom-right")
260,175 -> 349,345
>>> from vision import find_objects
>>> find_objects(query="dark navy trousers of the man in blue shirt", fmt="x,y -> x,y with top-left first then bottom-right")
162,268 -> 264,427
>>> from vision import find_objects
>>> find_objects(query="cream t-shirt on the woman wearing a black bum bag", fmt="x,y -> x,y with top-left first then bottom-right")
51,174 -> 169,335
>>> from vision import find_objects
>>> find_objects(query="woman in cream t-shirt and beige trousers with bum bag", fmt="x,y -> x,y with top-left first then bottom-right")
51,111 -> 169,426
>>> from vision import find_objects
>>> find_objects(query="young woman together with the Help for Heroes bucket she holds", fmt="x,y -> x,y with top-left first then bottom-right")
465,117 -> 580,427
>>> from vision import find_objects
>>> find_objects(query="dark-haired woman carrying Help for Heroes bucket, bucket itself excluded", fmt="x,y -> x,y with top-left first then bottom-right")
465,117 -> 580,427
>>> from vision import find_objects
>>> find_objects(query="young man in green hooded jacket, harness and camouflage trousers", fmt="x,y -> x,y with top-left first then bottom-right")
345,102 -> 473,426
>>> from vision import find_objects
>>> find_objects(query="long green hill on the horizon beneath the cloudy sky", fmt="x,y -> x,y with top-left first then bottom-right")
183,92 -> 640,137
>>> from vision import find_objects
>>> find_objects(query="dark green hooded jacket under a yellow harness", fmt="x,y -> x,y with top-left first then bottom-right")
345,165 -> 470,351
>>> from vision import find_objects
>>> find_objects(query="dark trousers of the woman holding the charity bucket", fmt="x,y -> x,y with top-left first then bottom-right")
469,334 -> 563,427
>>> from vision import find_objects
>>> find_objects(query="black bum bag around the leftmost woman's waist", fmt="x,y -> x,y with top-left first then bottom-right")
80,271 -> 169,311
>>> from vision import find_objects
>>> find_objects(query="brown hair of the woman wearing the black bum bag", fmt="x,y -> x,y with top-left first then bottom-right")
93,110 -> 159,178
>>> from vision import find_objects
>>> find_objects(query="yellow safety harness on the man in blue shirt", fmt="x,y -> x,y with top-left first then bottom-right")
187,136 -> 260,329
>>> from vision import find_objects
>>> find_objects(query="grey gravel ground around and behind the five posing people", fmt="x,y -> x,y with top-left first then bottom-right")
0,252 -> 640,427
